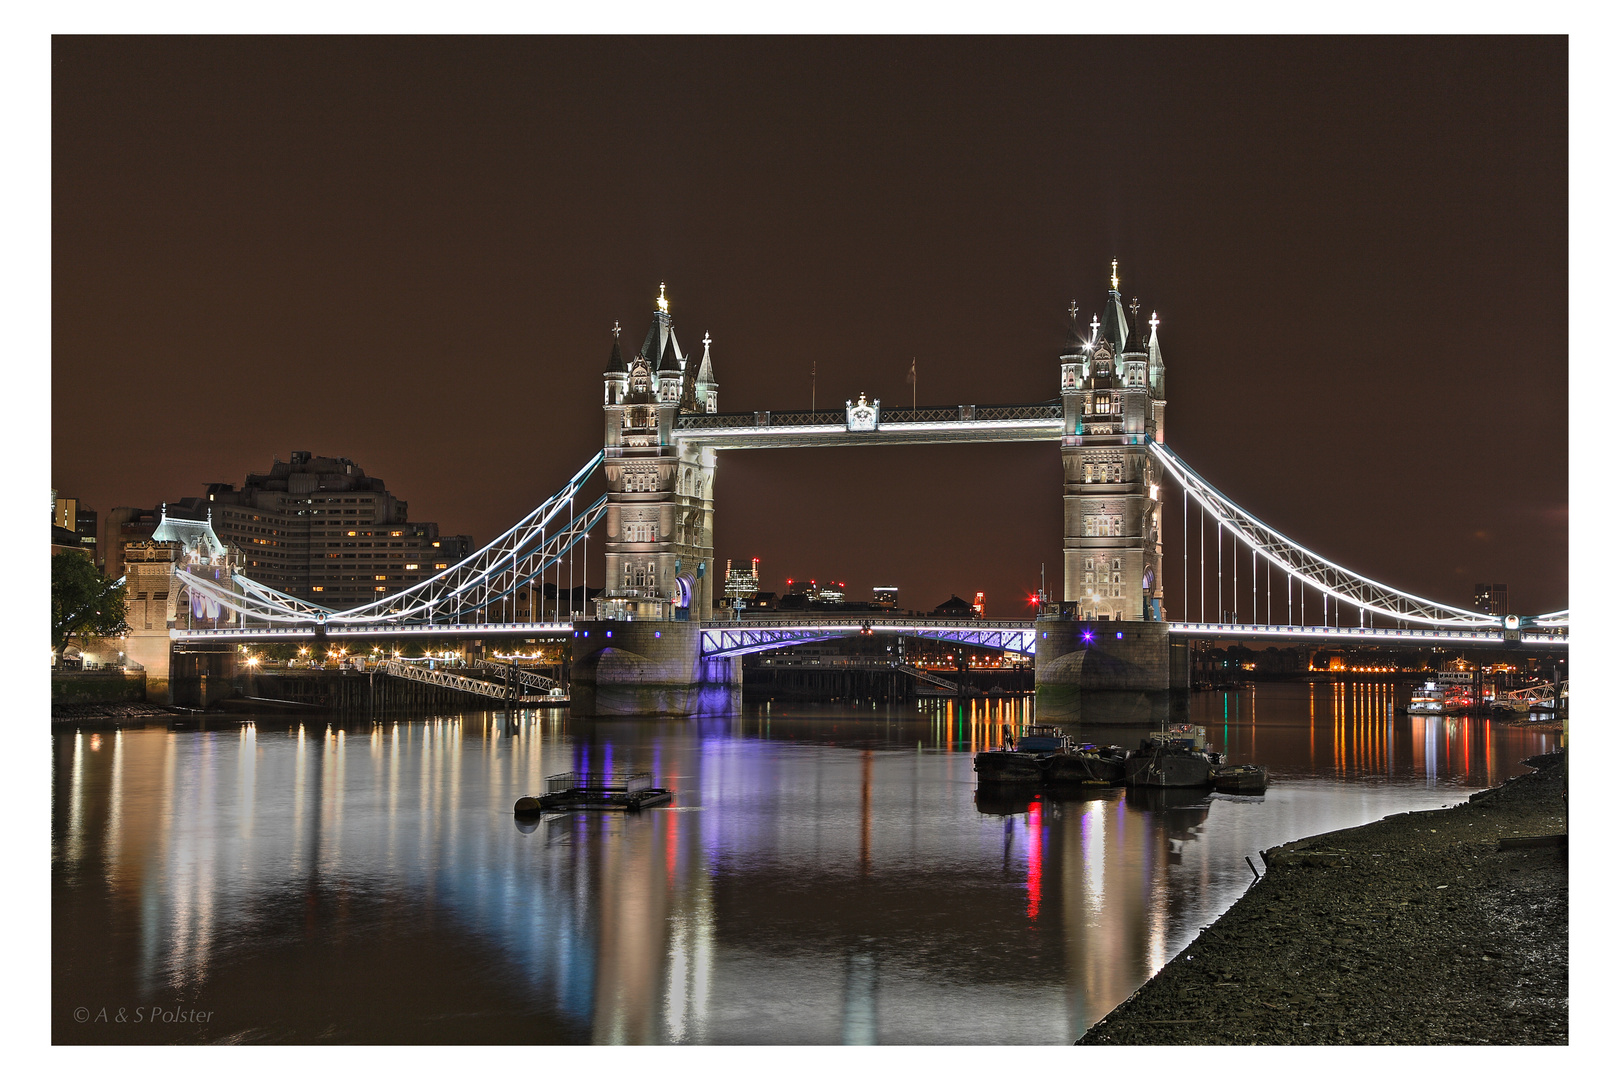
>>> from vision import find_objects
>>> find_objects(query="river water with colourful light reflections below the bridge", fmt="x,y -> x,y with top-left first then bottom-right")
50,683 -> 1557,1044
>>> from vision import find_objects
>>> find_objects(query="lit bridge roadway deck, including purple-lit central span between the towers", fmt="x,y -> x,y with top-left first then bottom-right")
168,612 -> 1570,657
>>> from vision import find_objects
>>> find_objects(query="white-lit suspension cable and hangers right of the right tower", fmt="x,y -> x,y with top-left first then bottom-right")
1149,442 -> 1570,628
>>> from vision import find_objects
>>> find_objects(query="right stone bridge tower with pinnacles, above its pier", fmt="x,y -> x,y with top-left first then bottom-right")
1061,262 -> 1165,622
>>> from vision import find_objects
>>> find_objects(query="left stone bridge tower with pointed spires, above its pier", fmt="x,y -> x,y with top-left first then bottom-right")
599,285 -> 719,620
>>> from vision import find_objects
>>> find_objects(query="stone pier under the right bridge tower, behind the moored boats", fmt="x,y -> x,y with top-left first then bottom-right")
1035,617 -> 1189,725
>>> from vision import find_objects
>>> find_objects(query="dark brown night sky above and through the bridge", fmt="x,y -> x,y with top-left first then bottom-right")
50,37 -> 1570,617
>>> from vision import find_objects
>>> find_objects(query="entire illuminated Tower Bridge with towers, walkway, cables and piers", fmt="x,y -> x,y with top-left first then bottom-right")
154,264 -> 1568,719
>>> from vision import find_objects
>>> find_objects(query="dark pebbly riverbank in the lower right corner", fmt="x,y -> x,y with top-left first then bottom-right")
1079,755 -> 1570,1046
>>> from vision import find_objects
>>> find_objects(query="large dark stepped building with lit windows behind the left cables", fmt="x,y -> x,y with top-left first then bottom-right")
178,450 -> 471,610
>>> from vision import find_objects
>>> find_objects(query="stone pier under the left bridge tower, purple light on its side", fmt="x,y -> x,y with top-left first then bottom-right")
569,620 -> 742,716
